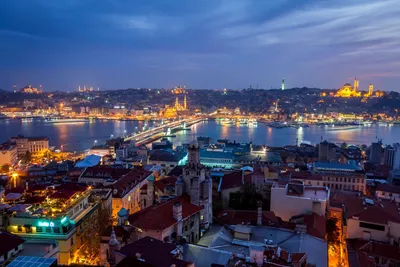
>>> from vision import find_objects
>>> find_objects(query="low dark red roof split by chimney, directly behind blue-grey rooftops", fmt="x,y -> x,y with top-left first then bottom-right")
217,210 -> 279,227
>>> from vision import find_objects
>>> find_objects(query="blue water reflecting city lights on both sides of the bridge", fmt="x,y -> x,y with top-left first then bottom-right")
0,119 -> 400,151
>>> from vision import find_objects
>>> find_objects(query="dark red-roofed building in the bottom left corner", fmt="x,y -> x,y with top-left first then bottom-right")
0,232 -> 25,266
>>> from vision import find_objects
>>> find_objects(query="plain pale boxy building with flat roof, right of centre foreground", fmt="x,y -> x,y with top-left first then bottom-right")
271,181 -> 330,221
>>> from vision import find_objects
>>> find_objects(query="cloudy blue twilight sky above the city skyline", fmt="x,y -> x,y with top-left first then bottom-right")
0,0 -> 400,91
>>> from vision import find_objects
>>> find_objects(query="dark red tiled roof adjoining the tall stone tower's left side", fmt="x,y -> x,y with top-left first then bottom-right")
129,194 -> 201,231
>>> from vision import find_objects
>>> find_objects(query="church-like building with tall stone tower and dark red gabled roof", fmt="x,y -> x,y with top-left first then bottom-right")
129,141 -> 212,243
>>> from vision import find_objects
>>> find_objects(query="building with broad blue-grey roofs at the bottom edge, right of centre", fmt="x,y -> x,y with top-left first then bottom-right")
183,224 -> 328,267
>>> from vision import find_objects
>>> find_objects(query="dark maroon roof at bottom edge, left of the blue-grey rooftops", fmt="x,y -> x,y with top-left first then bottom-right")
119,237 -> 190,267
